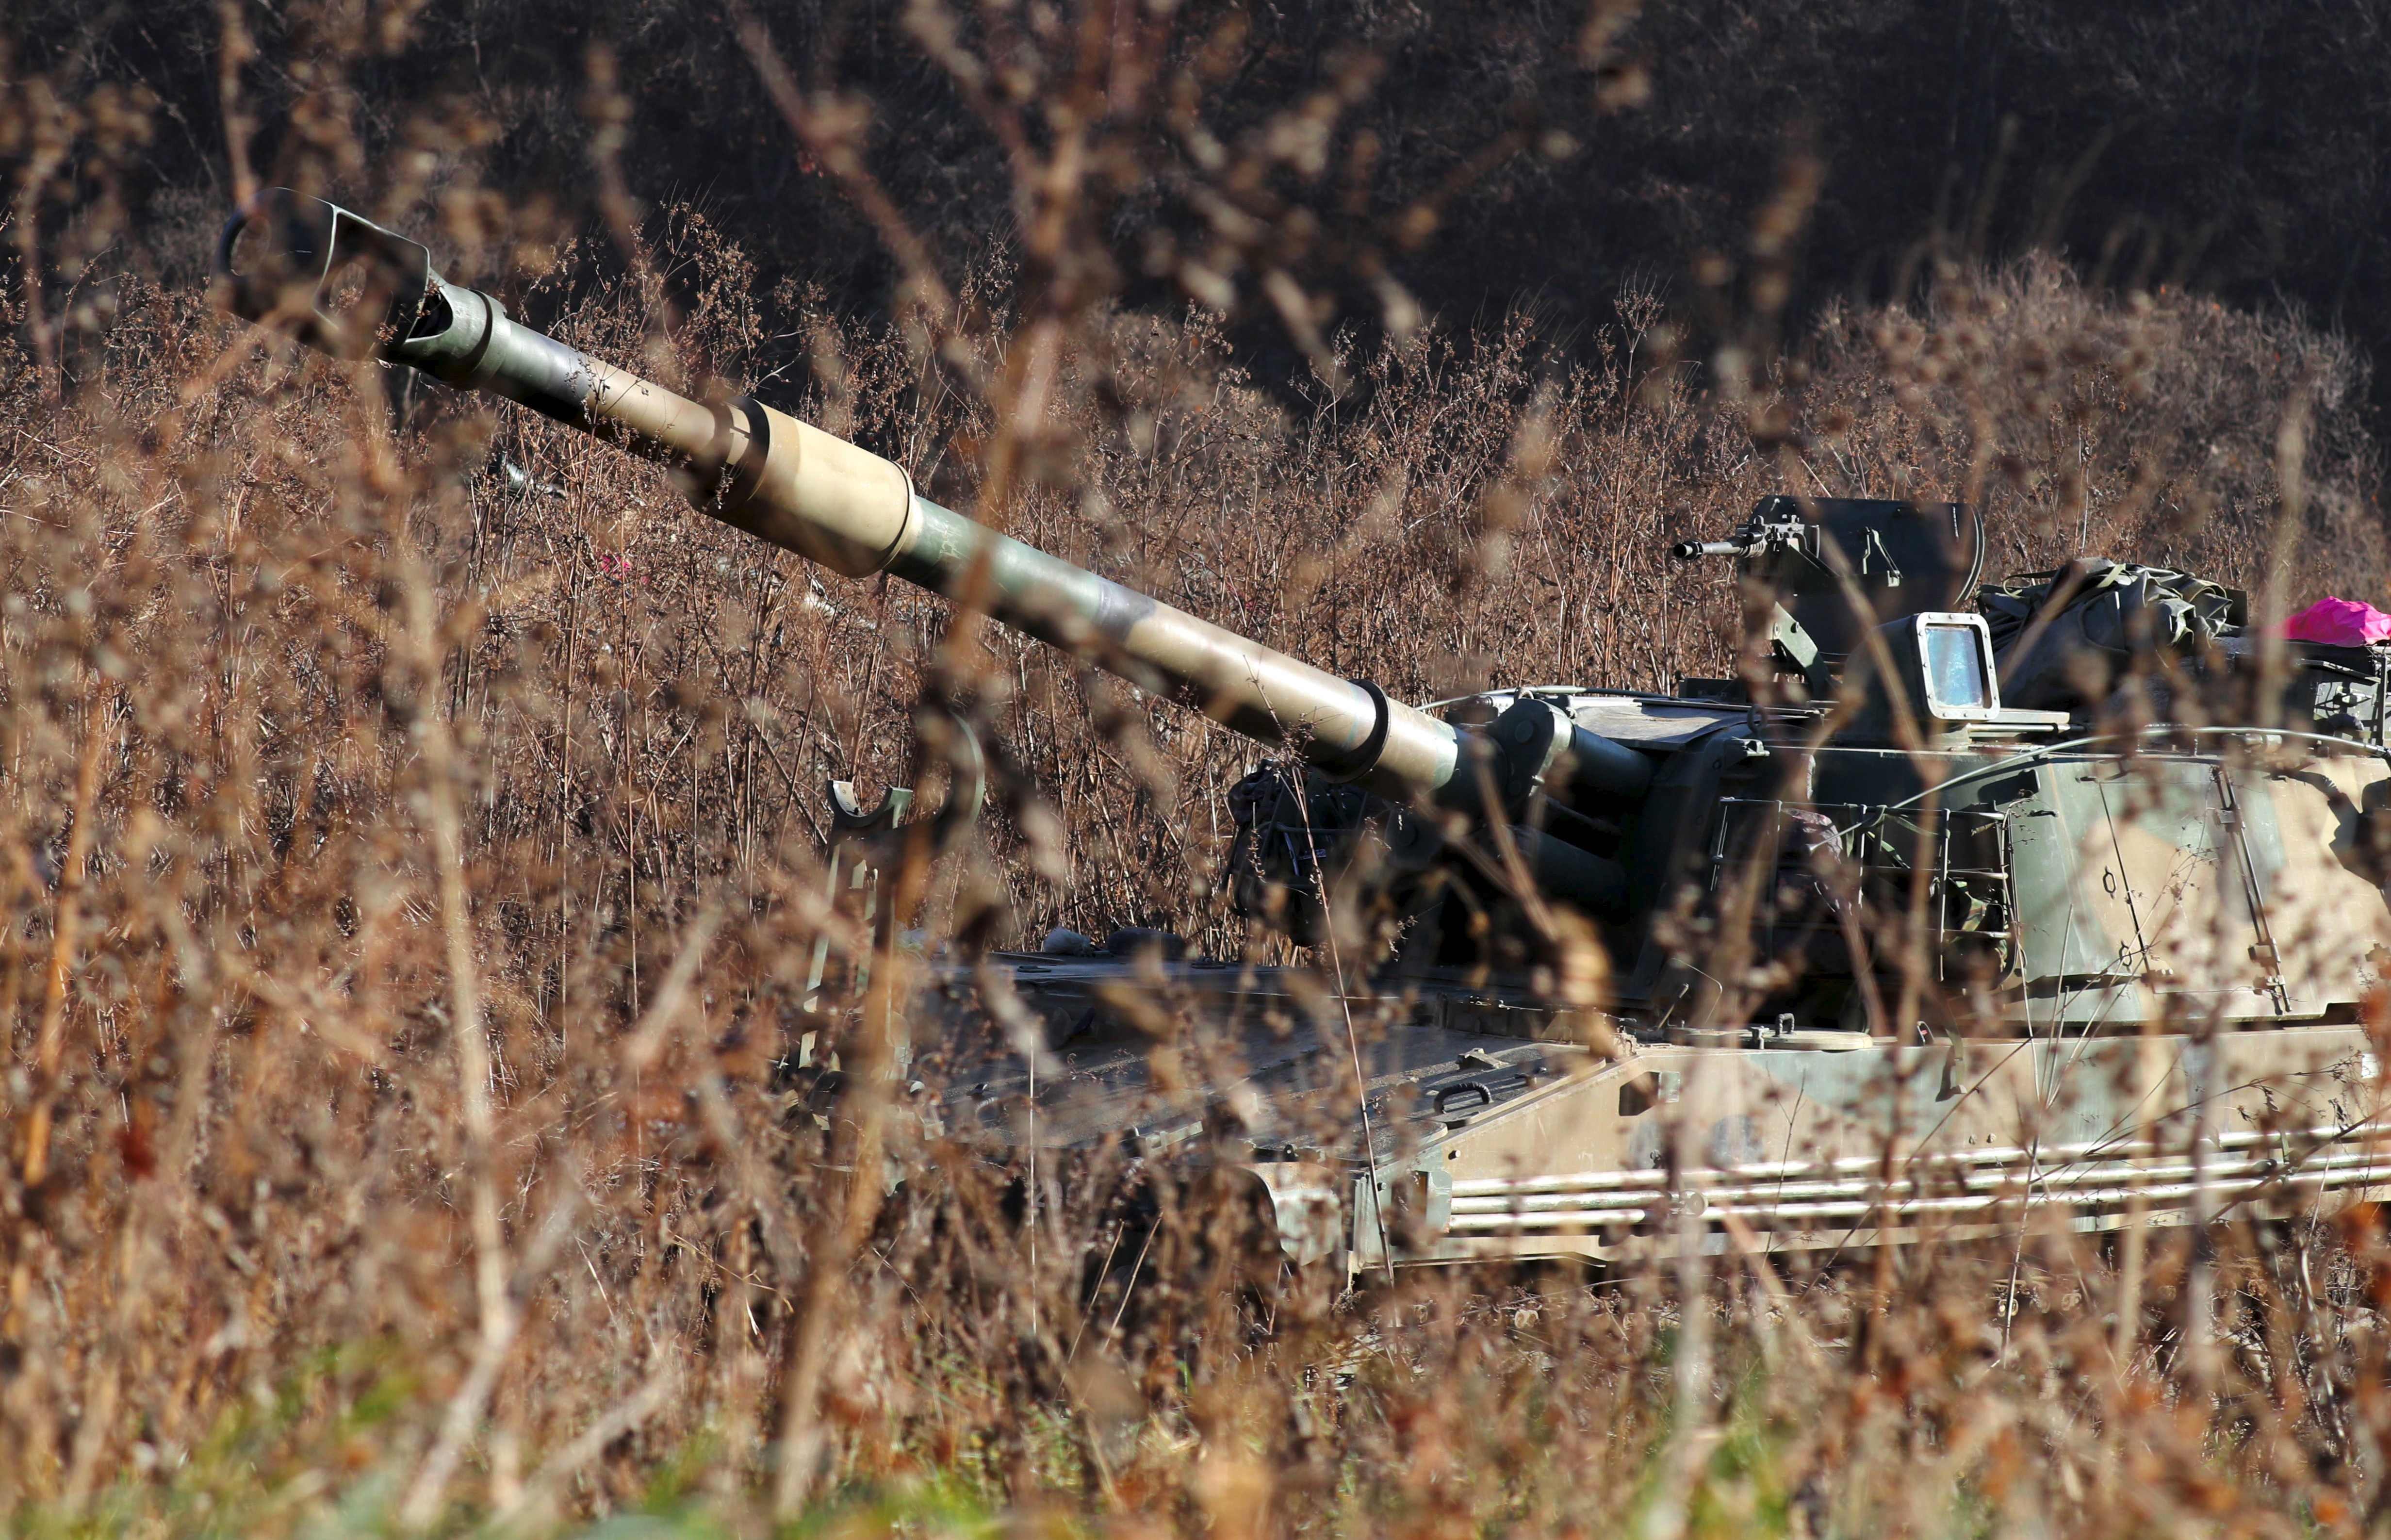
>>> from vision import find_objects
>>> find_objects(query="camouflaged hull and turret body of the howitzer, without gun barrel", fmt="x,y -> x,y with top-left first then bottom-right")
923,691 -> 2391,1270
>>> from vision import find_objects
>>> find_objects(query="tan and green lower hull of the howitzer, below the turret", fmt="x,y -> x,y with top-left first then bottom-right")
935,956 -> 2391,1272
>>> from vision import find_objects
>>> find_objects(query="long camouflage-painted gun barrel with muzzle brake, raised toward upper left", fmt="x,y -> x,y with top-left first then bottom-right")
217,189 -> 1458,799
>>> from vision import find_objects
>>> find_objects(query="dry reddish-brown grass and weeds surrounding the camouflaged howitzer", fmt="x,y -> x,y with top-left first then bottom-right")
0,6 -> 2391,1535
